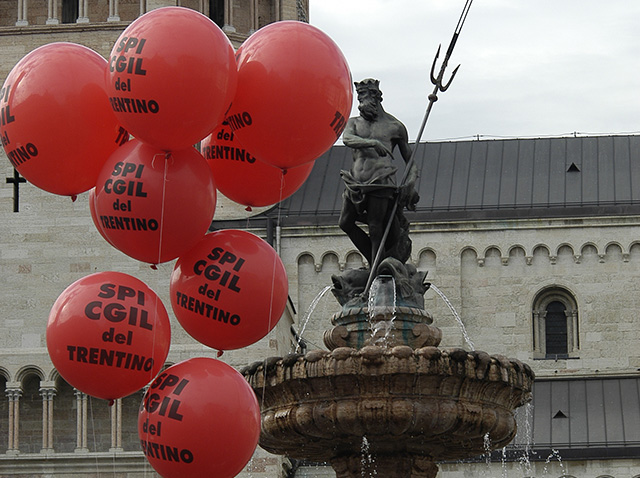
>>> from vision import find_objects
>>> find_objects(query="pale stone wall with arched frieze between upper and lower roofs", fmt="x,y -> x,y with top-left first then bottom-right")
283,217 -> 640,376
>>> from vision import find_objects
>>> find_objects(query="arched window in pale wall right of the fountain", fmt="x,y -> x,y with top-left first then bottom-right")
532,287 -> 579,359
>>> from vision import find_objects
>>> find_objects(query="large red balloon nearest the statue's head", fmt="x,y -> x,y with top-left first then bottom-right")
226,21 -> 353,169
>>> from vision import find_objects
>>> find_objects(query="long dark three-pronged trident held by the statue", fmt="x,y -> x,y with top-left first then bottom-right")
363,0 -> 473,297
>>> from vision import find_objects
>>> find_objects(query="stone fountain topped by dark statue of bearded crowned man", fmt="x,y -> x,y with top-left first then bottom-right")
242,80 -> 534,478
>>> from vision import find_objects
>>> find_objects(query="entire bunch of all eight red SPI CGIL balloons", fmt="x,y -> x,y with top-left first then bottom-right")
5,7 -> 352,477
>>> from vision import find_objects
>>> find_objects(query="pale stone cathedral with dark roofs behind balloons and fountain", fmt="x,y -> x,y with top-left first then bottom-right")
0,0 -> 640,478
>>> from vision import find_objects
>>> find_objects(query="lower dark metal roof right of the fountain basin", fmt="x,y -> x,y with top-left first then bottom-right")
510,377 -> 640,460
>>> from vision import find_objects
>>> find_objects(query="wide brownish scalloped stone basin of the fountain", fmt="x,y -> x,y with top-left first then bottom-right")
242,345 -> 534,478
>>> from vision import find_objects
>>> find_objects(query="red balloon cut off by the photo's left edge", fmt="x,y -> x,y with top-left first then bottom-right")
0,42 -> 129,196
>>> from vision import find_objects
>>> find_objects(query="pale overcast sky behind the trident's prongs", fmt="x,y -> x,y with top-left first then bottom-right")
309,0 -> 640,141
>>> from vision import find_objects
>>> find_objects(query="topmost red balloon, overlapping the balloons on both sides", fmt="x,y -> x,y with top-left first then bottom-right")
106,7 -> 238,150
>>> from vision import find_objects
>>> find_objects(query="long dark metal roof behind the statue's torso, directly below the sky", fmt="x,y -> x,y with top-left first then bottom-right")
239,135 -> 640,225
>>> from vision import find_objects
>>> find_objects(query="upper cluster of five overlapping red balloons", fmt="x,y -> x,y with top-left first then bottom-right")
0,11 -> 352,264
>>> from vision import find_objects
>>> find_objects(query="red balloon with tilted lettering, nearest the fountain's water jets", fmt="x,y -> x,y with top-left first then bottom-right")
170,229 -> 289,350
